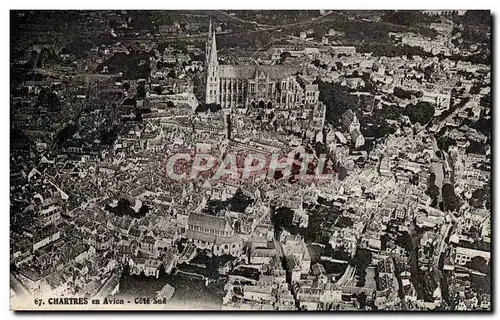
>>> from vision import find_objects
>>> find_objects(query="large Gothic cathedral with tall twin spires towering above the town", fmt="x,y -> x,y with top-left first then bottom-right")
205,24 -> 319,110
